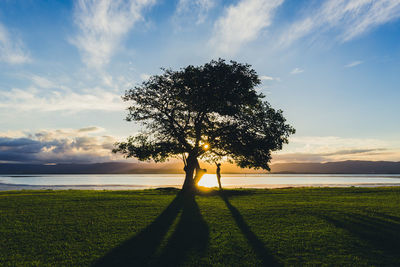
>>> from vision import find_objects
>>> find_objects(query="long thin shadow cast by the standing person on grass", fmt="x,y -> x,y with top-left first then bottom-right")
220,191 -> 281,266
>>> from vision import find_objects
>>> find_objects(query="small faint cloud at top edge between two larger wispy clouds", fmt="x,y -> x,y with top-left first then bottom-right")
173,0 -> 215,27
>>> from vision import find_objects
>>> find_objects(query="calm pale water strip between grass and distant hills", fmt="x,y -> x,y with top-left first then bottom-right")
0,174 -> 400,190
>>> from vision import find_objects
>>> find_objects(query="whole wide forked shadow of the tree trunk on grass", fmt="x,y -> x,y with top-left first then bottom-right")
93,191 -> 209,266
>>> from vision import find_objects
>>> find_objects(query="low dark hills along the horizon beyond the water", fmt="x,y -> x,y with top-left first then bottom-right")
0,161 -> 400,174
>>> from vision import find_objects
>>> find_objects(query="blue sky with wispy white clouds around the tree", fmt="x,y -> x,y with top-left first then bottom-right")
0,0 -> 400,164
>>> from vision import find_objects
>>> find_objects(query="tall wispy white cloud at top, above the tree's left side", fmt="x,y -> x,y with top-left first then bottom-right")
71,0 -> 155,68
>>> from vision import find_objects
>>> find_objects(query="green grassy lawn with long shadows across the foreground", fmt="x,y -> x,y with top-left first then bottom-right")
0,188 -> 400,266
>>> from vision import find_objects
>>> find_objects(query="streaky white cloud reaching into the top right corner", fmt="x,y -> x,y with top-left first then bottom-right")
279,0 -> 400,45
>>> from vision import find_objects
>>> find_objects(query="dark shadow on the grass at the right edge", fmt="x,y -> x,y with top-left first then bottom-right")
323,213 -> 400,266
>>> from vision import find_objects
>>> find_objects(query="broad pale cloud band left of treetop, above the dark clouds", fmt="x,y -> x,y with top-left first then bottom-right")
0,70 -> 135,115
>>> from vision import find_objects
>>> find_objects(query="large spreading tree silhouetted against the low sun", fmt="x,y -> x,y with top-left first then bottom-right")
113,59 -> 295,190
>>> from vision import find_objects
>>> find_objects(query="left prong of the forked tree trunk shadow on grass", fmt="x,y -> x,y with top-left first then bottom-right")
93,193 -> 183,266
